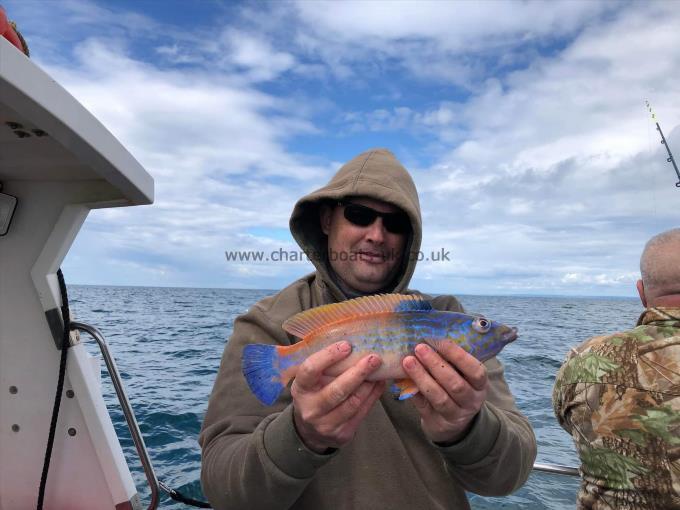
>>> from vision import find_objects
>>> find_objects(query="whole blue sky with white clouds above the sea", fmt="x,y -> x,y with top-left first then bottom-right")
0,0 -> 680,296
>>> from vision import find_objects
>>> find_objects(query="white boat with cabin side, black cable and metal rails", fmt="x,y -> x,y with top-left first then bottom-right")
0,11 -> 578,510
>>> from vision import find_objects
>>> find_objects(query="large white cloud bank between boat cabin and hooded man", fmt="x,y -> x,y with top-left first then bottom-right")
29,31 -> 328,285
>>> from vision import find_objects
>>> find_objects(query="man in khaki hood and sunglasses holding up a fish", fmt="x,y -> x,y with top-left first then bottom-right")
199,149 -> 536,510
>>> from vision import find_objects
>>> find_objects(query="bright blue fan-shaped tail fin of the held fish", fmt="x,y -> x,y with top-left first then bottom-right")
241,344 -> 288,405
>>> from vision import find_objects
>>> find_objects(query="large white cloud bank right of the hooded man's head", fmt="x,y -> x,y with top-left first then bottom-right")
378,3 -> 680,293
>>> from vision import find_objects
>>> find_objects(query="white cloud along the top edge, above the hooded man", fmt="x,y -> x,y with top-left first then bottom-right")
295,0 -> 616,88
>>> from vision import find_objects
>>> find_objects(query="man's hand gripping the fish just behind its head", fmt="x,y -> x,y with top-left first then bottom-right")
403,342 -> 488,443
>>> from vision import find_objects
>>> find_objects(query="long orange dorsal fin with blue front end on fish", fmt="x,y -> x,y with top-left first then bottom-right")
283,294 -> 432,338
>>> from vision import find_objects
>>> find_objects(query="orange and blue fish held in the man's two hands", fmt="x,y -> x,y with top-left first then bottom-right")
241,294 -> 517,405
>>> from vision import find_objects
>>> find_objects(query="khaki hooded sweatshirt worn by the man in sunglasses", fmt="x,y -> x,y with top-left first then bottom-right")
199,149 -> 536,510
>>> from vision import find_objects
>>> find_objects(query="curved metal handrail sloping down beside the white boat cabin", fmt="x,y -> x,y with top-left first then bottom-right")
71,321 -> 159,510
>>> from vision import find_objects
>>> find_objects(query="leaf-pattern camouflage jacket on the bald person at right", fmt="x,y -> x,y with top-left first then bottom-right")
553,308 -> 680,510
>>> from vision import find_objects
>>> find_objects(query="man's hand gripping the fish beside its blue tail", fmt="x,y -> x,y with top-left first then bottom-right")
290,342 -> 385,453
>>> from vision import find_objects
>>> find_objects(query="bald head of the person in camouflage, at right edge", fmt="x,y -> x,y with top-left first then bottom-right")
638,228 -> 680,306
